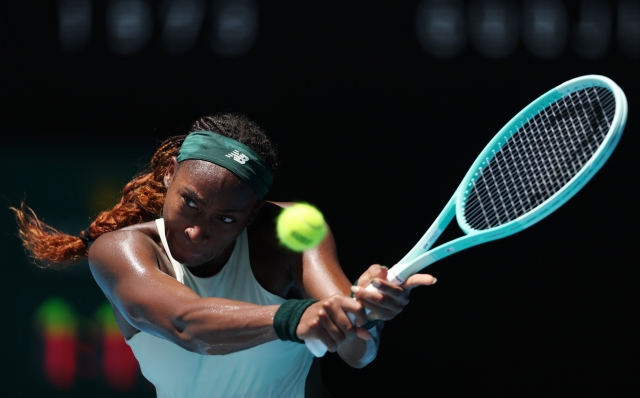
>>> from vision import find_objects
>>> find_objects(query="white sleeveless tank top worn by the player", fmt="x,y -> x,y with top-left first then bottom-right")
127,219 -> 313,398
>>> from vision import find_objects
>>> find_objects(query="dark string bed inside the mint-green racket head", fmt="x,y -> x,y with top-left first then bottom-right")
464,87 -> 615,230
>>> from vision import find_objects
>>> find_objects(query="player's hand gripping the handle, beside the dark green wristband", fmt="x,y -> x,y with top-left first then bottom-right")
296,294 -> 371,352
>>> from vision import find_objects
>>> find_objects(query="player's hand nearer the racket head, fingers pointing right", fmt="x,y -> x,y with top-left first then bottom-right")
351,264 -> 436,321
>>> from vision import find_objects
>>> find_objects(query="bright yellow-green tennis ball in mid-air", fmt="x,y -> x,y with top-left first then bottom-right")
276,203 -> 327,252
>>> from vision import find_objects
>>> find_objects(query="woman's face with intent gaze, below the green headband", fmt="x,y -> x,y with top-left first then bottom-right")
163,158 -> 264,267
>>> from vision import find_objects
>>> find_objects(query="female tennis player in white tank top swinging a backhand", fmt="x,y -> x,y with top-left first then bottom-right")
13,114 -> 435,397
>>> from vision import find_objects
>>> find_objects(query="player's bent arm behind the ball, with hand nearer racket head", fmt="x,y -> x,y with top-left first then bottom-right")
291,224 -> 435,368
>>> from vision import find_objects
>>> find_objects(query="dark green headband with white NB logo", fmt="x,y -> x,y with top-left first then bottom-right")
178,130 -> 273,200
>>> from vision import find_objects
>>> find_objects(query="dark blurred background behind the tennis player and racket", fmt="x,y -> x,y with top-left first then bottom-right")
0,0 -> 640,397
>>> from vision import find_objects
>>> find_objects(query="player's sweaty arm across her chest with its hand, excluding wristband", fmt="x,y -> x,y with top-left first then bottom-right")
89,230 -> 366,354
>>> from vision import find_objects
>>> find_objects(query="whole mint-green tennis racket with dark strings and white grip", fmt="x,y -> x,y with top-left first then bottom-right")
305,75 -> 627,357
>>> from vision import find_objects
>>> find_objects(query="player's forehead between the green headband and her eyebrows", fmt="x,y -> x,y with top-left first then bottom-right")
174,160 -> 257,206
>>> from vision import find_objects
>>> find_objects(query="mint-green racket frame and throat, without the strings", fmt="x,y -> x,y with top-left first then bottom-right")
387,75 -> 627,285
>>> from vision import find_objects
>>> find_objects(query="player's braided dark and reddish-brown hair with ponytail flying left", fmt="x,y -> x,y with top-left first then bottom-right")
10,113 -> 278,269
